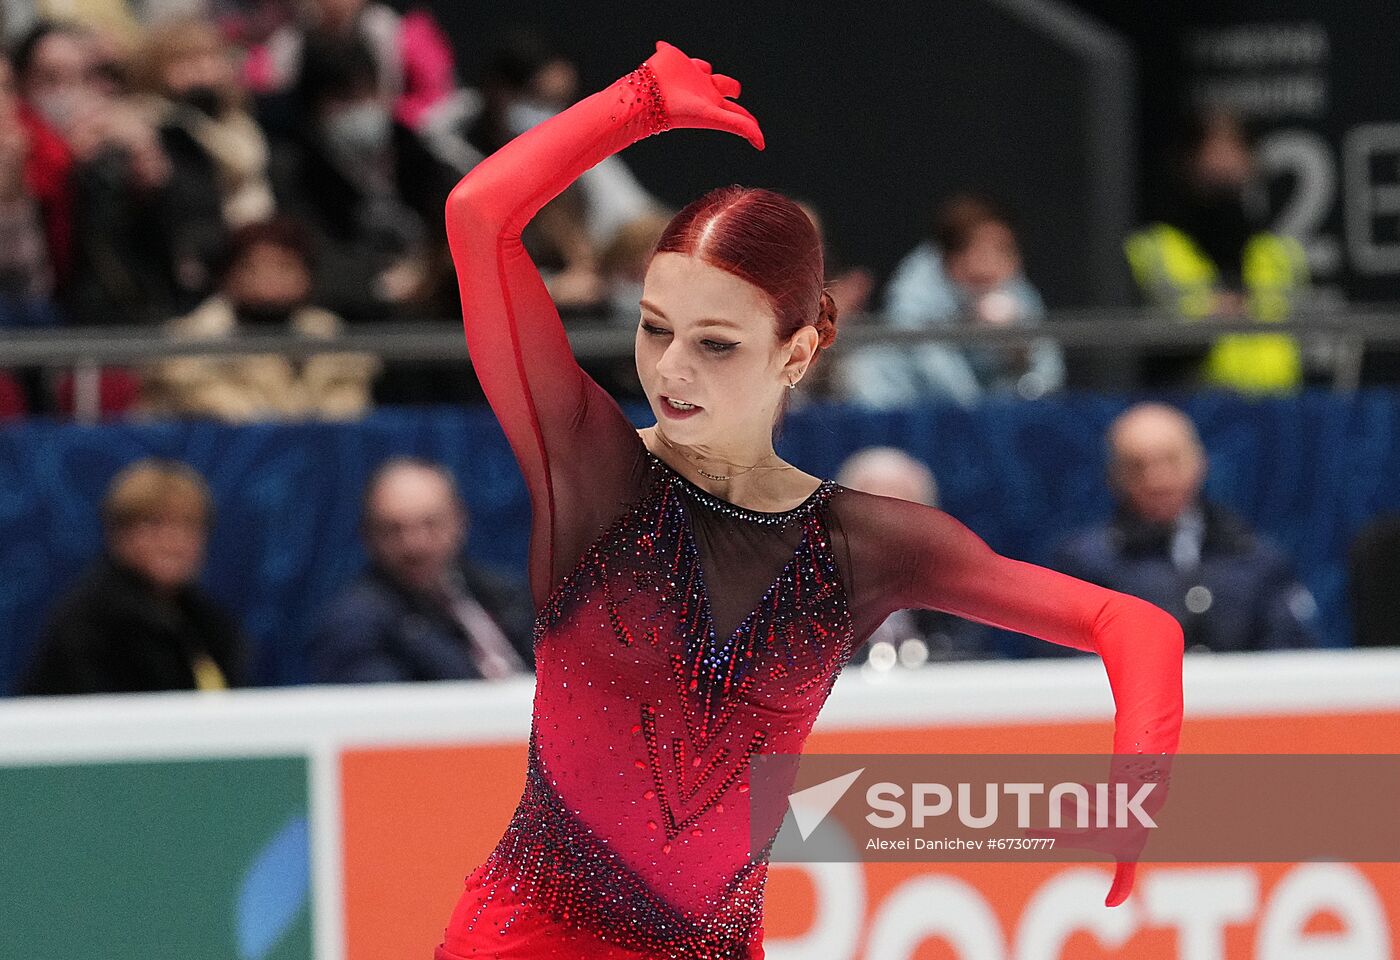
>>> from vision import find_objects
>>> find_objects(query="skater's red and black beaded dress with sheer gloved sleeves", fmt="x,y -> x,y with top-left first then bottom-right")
437,43 -> 1182,960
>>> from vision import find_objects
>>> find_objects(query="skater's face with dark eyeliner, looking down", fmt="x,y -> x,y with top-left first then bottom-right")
636,253 -> 816,449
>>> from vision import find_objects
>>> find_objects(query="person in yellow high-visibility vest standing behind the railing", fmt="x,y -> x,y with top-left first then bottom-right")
1124,115 -> 1308,393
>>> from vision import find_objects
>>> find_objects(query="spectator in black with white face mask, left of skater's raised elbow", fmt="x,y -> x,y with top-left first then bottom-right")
273,32 -> 458,327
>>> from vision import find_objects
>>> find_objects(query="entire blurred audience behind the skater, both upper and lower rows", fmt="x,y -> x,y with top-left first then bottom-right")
0,0 -> 1400,694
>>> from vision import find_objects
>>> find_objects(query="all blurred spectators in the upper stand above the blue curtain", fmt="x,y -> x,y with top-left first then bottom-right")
0,0 -> 1332,421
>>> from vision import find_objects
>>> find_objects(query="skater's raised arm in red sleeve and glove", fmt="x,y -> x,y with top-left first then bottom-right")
447,43 -> 763,603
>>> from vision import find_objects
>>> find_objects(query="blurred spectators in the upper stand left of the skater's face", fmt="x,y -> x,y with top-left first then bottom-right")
0,0 -> 665,420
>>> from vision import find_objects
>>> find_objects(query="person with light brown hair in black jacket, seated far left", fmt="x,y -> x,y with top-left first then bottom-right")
20,460 -> 246,694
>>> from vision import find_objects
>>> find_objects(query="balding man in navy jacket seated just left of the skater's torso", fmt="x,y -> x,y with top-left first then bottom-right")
311,459 -> 535,683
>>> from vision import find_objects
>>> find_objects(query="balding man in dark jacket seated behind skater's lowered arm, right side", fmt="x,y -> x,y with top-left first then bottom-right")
1037,403 -> 1317,655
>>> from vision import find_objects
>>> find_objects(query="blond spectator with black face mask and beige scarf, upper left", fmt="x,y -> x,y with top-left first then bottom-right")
136,18 -> 274,305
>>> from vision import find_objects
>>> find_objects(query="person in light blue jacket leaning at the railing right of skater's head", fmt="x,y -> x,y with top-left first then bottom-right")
840,195 -> 1064,409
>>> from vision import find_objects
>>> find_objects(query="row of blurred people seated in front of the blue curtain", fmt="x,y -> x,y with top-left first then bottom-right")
15,402 -> 1400,696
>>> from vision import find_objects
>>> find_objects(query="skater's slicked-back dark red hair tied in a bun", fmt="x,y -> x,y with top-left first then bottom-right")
654,186 -> 836,355
